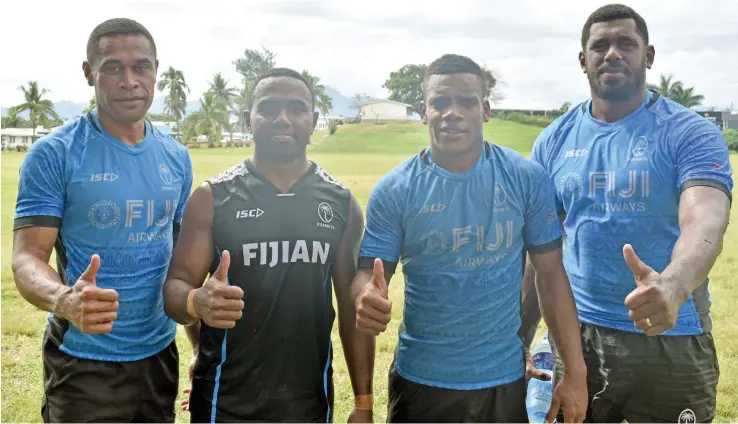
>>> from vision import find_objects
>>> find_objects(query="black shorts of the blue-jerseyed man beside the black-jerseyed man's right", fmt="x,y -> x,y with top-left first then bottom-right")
387,363 -> 528,423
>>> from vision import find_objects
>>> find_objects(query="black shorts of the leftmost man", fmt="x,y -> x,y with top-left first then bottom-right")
41,331 -> 179,423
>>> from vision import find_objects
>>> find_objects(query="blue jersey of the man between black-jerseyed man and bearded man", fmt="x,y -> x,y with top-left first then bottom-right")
360,143 -> 561,390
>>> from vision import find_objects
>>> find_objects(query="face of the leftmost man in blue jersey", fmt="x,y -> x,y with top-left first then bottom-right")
83,34 -> 159,124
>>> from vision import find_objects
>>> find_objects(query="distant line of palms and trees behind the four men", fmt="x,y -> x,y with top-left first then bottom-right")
2,47 -> 724,144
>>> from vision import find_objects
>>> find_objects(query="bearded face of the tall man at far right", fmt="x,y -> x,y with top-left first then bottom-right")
579,19 -> 654,101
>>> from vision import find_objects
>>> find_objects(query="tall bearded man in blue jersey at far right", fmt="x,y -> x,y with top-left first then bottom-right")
525,5 -> 733,422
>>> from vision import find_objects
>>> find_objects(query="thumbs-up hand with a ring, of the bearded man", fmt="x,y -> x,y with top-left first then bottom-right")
623,244 -> 686,336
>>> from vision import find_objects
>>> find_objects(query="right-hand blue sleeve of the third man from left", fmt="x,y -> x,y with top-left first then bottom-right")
523,168 -> 562,254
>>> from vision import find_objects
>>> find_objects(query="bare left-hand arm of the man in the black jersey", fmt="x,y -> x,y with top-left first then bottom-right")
164,183 -> 213,326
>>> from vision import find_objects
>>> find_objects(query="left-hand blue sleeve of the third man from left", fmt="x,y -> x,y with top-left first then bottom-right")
359,174 -> 404,273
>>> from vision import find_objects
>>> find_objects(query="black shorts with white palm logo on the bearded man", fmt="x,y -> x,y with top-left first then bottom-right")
554,323 -> 720,423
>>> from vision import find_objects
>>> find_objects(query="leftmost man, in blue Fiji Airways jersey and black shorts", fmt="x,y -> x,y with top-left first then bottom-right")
13,19 -> 192,422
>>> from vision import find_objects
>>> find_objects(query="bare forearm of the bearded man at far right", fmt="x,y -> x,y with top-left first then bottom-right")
662,186 -> 730,305
